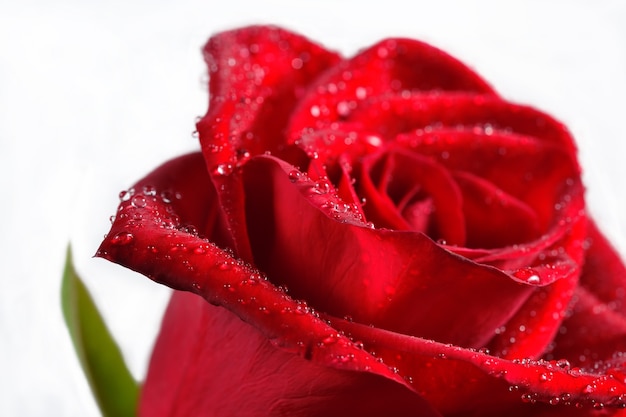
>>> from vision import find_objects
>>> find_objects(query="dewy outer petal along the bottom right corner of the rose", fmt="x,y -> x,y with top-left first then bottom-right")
327,317 -> 626,416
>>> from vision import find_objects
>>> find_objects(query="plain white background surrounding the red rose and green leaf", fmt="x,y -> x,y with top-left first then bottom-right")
0,0 -> 626,416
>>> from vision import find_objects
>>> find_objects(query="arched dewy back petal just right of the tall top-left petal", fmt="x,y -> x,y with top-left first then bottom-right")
288,39 -> 495,142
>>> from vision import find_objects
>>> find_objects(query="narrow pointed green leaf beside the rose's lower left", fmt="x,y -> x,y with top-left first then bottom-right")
61,246 -> 139,417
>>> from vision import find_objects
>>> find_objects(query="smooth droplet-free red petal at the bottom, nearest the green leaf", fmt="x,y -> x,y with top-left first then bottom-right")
139,292 -> 439,417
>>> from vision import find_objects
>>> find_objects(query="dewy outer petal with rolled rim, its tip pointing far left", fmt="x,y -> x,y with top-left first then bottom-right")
96,154 -> 428,396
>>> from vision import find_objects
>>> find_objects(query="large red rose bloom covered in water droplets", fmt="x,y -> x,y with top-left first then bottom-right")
98,27 -> 626,417
